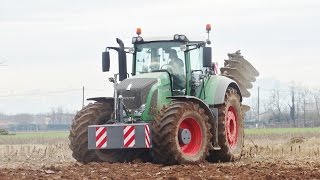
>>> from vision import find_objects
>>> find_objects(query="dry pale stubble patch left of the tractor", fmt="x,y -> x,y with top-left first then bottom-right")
0,132 -> 75,168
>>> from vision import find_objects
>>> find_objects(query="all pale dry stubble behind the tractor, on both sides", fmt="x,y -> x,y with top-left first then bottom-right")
0,129 -> 320,168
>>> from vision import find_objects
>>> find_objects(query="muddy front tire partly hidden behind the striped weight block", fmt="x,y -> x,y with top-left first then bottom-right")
69,102 -> 135,164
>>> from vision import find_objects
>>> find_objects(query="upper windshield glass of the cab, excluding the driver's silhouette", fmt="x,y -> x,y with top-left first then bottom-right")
133,41 -> 185,74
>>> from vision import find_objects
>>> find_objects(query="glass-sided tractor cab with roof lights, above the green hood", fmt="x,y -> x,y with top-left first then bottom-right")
132,29 -> 212,97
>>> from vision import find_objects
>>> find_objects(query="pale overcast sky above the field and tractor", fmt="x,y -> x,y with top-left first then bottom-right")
0,0 -> 320,114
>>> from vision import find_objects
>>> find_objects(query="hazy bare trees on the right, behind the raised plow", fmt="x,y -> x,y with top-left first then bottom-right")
246,83 -> 320,127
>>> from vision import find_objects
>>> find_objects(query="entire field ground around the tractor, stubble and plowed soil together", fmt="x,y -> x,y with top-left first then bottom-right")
0,128 -> 320,179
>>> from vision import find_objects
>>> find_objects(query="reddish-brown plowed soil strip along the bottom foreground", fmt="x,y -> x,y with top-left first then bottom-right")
0,161 -> 320,179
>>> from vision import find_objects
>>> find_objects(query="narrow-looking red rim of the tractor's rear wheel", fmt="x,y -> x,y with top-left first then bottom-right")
226,106 -> 239,149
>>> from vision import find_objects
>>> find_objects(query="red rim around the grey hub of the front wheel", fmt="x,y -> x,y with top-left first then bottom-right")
179,117 -> 202,155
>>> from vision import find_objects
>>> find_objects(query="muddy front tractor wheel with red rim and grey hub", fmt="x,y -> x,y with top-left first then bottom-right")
152,101 -> 211,165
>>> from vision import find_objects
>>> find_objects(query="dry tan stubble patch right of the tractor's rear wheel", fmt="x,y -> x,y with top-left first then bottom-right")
244,133 -> 320,162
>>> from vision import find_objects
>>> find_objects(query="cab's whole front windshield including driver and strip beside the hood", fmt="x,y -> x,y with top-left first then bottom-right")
132,41 -> 187,95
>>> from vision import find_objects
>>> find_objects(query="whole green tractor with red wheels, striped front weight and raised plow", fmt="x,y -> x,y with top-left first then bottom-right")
69,25 -> 257,164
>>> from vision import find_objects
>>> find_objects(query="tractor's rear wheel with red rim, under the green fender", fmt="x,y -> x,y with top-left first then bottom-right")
208,88 -> 244,162
